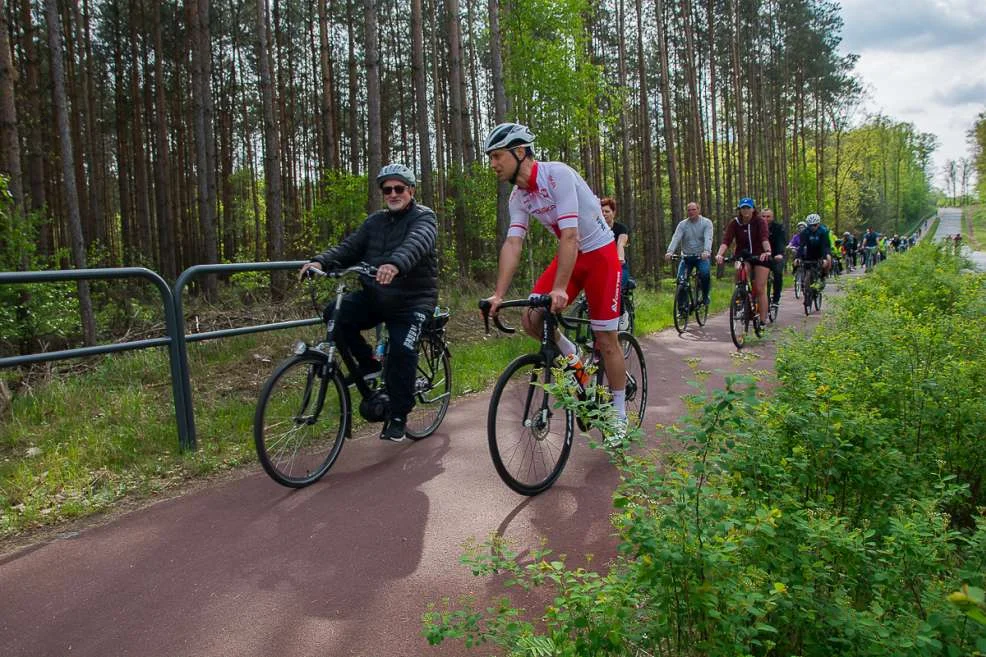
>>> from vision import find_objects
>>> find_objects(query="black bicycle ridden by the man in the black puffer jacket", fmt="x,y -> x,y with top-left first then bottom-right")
253,263 -> 452,488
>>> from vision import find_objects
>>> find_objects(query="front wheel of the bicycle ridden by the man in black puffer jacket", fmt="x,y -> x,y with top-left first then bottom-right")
253,355 -> 349,488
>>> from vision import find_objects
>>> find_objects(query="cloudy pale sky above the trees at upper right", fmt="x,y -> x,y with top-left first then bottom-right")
837,0 -> 986,187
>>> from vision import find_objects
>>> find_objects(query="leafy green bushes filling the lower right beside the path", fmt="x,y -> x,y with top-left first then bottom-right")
423,244 -> 986,657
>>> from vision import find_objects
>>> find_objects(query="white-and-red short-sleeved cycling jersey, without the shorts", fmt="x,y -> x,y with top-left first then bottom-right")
507,162 -> 613,253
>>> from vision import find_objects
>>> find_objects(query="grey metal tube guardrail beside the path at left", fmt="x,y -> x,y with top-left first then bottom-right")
0,260 -> 322,449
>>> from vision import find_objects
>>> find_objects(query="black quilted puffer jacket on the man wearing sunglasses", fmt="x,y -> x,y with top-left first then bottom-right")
312,200 -> 438,310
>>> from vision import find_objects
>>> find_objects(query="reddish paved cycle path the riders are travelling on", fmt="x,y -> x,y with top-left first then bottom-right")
0,280 -> 831,657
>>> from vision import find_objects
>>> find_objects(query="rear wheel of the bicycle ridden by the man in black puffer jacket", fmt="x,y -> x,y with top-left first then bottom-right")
406,335 -> 452,440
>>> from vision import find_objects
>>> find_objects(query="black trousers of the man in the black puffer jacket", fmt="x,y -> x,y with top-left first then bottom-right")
333,290 -> 433,417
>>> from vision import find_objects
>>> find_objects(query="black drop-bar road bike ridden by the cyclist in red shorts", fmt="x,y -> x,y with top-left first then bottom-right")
479,295 -> 647,495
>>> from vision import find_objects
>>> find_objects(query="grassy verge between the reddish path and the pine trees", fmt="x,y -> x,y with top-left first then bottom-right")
0,270 -> 729,538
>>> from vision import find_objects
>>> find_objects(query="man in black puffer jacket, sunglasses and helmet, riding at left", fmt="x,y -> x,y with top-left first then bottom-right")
301,164 -> 438,442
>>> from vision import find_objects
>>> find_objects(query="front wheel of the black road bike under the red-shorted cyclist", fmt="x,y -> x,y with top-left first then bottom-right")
486,354 -> 575,495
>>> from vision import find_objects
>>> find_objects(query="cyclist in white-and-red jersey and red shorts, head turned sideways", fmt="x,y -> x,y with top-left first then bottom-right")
483,123 -> 626,439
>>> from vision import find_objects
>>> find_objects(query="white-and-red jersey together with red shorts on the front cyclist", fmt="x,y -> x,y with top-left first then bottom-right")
507,162 -> 622,331
